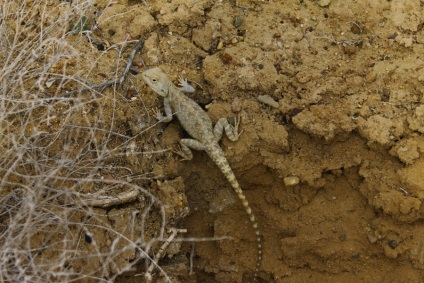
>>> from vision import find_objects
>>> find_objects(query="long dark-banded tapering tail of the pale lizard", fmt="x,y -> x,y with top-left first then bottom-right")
208,146 -> 262,281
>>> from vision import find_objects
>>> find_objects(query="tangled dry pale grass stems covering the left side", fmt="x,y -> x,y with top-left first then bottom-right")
0,0 -> 176,282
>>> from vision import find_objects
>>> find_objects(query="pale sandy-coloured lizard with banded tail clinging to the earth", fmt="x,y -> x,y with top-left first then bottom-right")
142,67 -> 262,281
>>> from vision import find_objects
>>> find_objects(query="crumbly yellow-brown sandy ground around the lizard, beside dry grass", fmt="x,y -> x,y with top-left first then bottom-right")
3,0 -> 424,282
